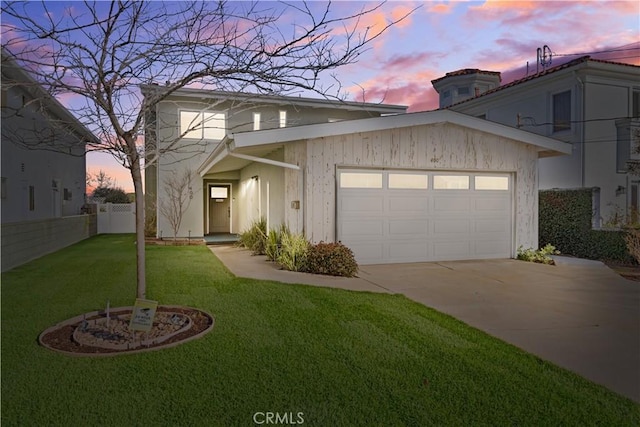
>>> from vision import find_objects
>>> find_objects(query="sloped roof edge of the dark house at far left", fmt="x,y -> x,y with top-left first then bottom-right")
2,48 -> 99,144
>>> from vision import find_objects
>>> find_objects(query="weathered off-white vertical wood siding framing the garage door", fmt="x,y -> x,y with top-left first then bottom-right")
285,124 -> 538,255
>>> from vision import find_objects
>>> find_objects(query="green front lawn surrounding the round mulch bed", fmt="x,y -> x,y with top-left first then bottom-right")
1,235 -> 640,427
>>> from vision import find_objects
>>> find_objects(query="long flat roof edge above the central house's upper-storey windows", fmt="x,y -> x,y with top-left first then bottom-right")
140,85 -> 408,114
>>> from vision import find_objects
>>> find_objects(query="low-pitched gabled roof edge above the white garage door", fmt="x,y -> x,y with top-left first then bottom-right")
198,110 -> 571,176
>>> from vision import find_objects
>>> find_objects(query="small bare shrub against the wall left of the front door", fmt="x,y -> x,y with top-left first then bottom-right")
158,169 -> 194,242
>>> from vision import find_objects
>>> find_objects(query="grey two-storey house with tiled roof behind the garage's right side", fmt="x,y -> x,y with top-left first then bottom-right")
432,56 -> 640,227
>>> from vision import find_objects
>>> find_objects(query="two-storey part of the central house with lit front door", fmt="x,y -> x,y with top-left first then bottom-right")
142,85 -> 407,238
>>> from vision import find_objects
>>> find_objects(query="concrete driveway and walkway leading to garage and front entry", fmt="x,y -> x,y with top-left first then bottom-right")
211,246 -> 640,402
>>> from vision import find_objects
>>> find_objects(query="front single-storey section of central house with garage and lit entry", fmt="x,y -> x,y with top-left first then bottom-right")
147,83 -> 571,264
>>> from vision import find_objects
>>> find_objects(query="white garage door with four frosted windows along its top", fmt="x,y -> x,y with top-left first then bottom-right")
337,169 -> 513,264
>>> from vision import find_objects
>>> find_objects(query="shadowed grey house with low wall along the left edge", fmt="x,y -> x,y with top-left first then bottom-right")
0,50 -> 96,271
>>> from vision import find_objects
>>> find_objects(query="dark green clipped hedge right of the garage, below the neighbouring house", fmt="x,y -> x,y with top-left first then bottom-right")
538,188 -> 635,264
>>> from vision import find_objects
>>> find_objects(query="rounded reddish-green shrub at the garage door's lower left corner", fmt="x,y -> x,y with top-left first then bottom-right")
307,242 -> 358,277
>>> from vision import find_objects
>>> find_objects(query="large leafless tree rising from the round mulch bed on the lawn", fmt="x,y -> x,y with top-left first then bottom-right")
2,0 -> 416,298
